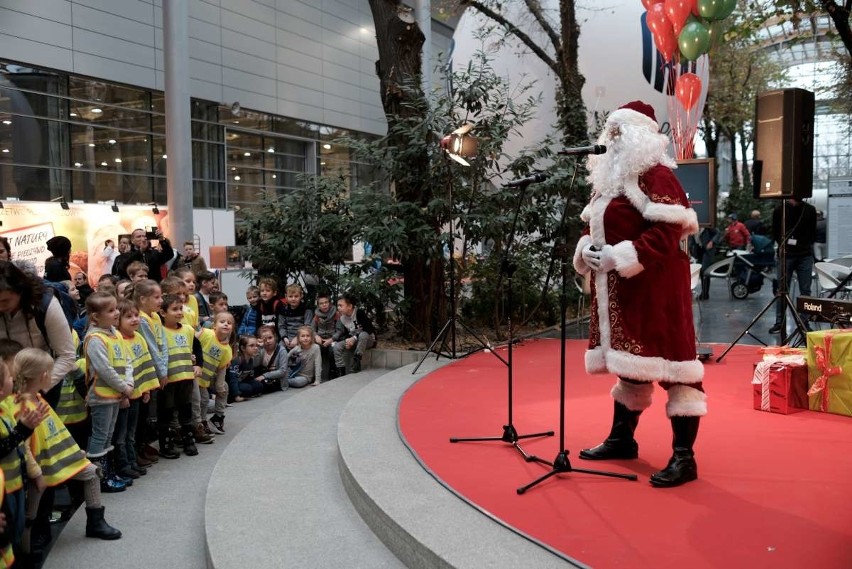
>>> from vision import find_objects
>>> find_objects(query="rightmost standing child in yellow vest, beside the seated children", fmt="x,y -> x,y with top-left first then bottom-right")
196,312 -> 231,435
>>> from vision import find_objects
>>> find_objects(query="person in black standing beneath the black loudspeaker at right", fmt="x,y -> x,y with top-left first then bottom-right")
769,198 -> 817,334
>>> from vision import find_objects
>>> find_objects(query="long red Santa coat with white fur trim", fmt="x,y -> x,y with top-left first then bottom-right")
574,165 -> 704,384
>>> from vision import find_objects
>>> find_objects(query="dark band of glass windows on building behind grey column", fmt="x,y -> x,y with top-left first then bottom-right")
0,60 -> 370,222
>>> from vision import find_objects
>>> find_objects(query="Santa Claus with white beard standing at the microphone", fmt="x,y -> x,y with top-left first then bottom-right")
574,101 -> 707,487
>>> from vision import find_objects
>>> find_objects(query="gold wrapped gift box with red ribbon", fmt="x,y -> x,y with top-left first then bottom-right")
808,330 -> 852,417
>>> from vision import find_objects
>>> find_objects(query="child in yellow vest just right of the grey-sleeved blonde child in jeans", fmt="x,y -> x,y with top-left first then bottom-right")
112,300 -> 160,479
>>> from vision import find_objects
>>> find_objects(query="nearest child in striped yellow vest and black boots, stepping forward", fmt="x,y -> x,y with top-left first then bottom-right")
14,348 -> 121,540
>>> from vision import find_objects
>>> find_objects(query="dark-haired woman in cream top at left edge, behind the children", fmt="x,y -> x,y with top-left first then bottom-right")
0,261 -> 77,392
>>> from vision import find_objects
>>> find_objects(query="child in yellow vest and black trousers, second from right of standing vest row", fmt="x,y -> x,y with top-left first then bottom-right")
157,294 -> 201,458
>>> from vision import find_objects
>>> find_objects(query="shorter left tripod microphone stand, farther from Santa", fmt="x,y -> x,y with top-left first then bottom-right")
450,176 -> 554,464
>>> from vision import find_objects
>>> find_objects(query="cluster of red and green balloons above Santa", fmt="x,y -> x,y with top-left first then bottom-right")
642,0 -> 737,110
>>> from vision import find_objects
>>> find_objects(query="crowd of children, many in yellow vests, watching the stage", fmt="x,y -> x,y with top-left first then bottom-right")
0,263 -> 375,567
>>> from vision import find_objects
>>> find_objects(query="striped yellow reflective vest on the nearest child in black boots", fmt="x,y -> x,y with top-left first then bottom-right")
26,395 -> 89,487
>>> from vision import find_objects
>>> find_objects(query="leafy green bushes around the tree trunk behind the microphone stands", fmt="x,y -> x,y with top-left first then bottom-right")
242,46 -> 586,340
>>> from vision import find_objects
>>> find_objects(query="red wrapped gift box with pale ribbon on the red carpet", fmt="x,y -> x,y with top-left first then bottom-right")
752,361 -> 808,415
